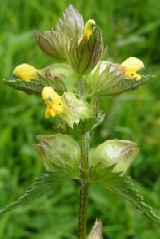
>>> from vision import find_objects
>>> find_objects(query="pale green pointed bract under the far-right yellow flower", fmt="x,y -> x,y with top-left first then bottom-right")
86,61 -> 154,98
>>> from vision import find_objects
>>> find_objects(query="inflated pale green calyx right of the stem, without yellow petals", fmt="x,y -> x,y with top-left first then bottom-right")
91,139 -> 139,173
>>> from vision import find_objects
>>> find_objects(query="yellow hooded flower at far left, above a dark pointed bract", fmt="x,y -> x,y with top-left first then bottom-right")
13,63 -> 37,81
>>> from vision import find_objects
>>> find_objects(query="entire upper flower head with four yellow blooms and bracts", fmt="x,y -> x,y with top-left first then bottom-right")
7,5 -> 148,128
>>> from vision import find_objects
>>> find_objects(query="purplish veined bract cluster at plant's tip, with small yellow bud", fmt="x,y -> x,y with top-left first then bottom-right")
36,5 -> 107,74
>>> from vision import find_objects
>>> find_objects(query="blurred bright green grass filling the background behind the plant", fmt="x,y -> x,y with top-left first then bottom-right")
0,0 -> 160,239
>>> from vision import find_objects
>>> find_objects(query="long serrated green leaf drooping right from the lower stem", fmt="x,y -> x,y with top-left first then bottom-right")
86,163 -> 160,226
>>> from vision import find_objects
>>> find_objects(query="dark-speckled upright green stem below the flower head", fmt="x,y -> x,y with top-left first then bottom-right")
78,134 -> 89,239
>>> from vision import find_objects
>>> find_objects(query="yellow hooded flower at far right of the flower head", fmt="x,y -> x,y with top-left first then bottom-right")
121,57 -> 145,80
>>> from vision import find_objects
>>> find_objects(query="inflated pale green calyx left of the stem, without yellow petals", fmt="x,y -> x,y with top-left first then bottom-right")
33,134 -> 80,170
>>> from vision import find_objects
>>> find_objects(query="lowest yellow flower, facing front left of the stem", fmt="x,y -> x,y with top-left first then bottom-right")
42,86 -> 65,118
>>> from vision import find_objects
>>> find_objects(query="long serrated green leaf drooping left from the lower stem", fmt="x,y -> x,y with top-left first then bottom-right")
0,165 -> 79,213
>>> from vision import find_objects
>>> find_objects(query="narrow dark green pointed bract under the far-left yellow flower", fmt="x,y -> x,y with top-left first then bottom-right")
3,79 -> 43,97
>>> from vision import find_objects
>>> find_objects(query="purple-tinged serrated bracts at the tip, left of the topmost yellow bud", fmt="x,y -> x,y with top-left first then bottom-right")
35,4 -> 84,62
